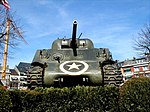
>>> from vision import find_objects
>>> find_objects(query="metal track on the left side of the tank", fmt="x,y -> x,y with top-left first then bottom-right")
27,66 -> 43,89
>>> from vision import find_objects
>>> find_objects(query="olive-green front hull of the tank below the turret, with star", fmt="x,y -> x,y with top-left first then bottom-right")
36,49 -> 102,86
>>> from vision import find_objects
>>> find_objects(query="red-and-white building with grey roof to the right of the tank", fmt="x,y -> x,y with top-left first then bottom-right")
118,57 -> 150,81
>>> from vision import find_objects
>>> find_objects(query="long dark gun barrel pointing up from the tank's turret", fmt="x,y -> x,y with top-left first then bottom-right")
71,21 -> 77,56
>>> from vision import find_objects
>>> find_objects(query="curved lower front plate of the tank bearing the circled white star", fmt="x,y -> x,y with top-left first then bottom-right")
44,60 -> 102,85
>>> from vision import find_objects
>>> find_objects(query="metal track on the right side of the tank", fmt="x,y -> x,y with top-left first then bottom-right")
103,64 -> 123,86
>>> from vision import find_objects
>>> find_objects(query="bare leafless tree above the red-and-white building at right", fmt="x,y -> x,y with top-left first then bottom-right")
133,24 -> 150,56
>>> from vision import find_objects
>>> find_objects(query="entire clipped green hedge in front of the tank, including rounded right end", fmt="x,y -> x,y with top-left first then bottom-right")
0,78 -> 150,112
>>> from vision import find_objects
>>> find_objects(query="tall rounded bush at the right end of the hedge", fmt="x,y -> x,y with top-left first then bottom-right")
120,77 -> 150,112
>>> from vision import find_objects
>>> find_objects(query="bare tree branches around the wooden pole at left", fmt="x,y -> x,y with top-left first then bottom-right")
0,5 -> 26,57
